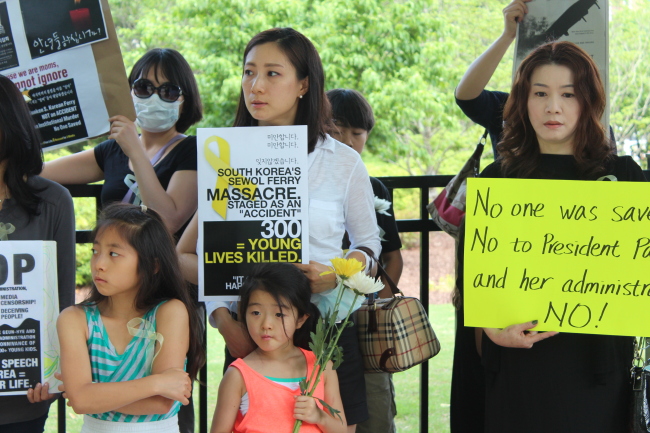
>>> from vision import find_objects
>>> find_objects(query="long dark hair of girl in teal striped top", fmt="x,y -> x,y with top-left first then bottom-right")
82,203 -> 205,380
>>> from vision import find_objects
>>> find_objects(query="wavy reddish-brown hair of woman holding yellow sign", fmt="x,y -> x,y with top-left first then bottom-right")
497,41 -> 613,179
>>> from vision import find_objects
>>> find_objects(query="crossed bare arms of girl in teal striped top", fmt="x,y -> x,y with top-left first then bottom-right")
57,301 -> 191,415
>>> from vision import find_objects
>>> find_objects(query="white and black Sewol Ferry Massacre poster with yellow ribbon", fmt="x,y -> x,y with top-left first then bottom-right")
197,126 -> 309,301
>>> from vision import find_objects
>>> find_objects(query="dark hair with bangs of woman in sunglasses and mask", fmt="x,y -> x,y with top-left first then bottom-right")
129,48 -> 203,132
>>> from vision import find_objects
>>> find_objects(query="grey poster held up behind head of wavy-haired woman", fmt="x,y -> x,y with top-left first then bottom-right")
513,0 -> 609,73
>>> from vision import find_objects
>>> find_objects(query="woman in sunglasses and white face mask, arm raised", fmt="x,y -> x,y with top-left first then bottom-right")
43,49 -> 202,238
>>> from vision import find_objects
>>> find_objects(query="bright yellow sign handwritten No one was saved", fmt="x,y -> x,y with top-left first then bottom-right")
463,179 -> 650,336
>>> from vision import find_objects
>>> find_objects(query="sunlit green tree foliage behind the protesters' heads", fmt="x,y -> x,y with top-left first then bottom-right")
106,0 -> 650,175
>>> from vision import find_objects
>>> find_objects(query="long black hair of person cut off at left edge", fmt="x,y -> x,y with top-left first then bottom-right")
0,75 -> 43,218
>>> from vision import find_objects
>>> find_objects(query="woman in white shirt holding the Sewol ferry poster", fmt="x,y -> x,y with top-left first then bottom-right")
178,28 -> 380,431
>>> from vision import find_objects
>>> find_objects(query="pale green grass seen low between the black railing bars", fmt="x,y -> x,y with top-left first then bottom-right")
45,304 -> 454,433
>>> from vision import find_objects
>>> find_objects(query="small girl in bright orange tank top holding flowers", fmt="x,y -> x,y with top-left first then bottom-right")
211,263 -> 347,433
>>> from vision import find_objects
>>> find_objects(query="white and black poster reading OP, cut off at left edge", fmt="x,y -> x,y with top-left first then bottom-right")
0,241 -> 59,395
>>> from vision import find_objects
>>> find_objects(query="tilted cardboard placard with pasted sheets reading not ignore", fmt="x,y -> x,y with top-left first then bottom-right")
0,0 -> 135,149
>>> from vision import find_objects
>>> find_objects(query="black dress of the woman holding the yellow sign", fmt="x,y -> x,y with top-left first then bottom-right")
474,154 -> 645,433
